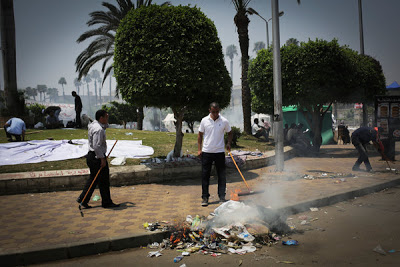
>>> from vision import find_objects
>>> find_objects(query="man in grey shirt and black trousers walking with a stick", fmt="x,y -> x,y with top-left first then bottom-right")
76,110 -> 119,209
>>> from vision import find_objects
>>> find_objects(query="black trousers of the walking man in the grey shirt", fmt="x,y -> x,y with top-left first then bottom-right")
78,151 -> 112,206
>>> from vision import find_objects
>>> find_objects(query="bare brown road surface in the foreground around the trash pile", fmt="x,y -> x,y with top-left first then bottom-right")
35,187 -> 400,267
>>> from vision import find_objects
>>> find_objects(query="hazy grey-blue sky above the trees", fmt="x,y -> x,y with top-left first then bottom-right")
0,0 -> 400,95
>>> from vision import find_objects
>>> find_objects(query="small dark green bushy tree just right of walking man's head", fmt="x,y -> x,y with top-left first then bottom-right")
102,101 -> 138,129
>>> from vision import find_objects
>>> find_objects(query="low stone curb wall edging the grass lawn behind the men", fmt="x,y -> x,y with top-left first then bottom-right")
0,146 -> 295,195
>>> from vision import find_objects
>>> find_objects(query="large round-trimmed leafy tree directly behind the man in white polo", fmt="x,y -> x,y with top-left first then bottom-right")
114,5 -> 232,156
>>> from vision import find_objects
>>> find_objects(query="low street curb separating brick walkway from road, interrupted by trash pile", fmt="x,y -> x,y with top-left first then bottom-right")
0,178 -> 400,266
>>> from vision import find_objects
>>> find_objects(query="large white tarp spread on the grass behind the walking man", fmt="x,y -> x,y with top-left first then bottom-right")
0,139 -> 154,166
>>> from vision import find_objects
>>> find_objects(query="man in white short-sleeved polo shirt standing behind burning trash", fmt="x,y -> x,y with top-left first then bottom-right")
197,102 -> 232,207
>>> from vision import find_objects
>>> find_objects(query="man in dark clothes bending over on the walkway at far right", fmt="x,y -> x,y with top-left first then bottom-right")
351,127 -> 383,172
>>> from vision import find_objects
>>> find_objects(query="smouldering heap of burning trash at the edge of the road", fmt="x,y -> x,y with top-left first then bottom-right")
148,200 -> 297,259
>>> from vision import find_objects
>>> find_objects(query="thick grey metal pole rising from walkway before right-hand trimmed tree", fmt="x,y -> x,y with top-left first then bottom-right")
271,0 -> 284,171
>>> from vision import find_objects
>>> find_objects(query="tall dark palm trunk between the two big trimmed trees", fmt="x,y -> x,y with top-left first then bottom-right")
232,0 -> 251,135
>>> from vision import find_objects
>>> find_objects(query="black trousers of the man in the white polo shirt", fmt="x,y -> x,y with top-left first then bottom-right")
201,152 -> 226,198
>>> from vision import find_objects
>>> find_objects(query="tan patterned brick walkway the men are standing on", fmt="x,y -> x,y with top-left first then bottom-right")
0,145 -> 400,254
